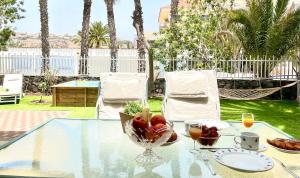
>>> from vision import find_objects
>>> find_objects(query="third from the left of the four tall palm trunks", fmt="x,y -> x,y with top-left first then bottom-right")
104,0 -> 118,72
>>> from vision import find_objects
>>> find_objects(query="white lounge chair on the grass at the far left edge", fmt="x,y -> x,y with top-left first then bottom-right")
0,74 -> 23,104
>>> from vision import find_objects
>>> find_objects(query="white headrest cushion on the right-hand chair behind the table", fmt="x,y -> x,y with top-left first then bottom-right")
166,72 -> 208,97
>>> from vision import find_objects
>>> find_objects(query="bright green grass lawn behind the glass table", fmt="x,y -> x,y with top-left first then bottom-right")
0,96 -> 300,139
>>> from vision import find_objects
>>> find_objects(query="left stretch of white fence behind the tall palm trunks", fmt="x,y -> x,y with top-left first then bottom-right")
0,48 -> 148,77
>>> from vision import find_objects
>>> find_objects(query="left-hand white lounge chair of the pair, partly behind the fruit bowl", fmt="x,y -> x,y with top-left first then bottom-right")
96,73 -> 147,119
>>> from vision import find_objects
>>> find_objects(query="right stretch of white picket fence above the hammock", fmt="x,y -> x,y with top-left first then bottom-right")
160,57 -> 300,80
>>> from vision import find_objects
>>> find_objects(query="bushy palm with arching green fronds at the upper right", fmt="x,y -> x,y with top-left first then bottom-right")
228,0 -> 300,58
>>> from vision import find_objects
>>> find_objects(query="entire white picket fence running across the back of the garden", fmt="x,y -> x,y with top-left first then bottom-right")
0,48 -> 300,80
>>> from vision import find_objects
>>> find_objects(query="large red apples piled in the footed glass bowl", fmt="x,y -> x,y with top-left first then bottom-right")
132,109 -> 177,143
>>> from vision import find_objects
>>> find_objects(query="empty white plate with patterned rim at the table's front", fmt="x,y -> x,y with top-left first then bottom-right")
215,148 -> 274,172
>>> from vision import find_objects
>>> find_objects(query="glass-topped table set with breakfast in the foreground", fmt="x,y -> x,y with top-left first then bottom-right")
0,119 -> 300,178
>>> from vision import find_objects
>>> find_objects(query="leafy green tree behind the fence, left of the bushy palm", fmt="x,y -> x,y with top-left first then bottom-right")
152,0 -> 232,70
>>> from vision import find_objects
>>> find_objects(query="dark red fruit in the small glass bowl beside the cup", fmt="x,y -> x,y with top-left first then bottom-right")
199,125 -> 219,146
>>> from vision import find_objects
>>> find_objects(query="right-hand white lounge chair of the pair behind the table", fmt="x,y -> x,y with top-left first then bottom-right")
162,70 -> 220,121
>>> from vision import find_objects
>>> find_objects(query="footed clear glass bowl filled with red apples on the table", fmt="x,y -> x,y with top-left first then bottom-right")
125,120 -> 173,165
